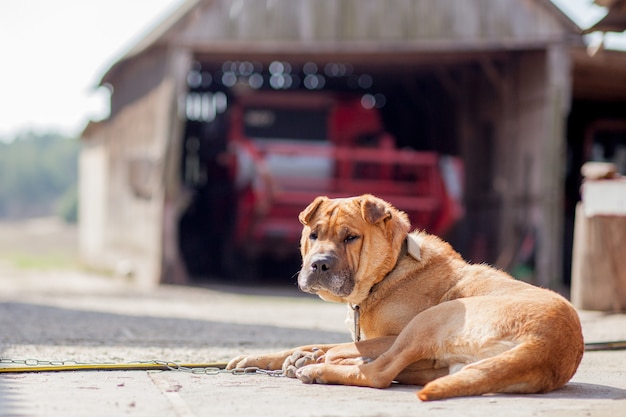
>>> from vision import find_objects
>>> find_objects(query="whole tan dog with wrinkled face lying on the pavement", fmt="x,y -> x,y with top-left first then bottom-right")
228,195 -> 584,401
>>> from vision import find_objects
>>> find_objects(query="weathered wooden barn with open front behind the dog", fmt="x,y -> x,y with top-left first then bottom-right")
79,0 -> 626,288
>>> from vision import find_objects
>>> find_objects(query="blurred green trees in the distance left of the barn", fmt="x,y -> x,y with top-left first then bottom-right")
0,133 -> 79,219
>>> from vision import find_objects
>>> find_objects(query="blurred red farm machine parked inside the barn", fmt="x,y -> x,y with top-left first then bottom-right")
216,91 -> 463,274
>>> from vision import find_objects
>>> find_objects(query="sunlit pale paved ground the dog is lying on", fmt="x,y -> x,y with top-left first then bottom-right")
0,263 -> 626,417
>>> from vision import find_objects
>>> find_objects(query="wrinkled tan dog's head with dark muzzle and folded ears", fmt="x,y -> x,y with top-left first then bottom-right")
298,194 -> 410,304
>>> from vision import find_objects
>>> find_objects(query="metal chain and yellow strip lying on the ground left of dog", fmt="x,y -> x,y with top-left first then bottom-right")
0,358 -> 284,377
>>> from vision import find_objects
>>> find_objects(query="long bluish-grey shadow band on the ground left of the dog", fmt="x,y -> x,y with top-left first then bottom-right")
0,302 -> 347,349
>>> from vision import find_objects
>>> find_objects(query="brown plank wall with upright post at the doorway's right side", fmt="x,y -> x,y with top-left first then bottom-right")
510,47 -> 571,288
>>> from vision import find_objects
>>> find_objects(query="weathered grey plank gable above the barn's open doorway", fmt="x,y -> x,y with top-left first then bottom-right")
171,0 -> 563,49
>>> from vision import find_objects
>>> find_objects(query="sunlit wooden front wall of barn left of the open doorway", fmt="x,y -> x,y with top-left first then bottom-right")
83,47 -> 176,285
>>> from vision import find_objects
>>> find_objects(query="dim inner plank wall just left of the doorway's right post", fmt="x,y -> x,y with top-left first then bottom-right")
497,51 -> 548,283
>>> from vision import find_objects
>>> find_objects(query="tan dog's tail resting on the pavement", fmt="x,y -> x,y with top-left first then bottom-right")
417,344 -> 582,401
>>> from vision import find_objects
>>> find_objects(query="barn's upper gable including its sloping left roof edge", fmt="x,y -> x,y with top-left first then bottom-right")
101,0 -> 581,84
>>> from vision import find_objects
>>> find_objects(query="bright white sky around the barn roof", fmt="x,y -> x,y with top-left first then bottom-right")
0,0 -> 626,141
